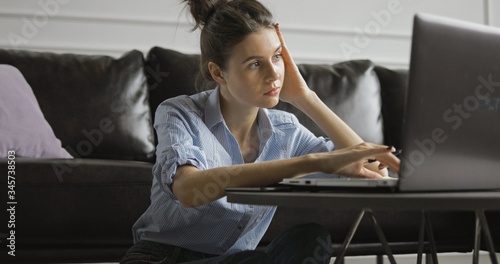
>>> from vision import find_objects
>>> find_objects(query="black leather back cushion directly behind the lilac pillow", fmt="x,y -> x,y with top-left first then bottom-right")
0,50 -> 154,160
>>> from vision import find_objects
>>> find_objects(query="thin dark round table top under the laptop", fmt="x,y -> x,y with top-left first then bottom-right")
227,189 -> 500,211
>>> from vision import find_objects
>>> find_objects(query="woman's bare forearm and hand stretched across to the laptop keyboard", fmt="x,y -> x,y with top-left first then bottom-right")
172,143 -> 393,207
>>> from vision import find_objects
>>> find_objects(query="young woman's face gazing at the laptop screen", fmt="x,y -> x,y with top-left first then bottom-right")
221,28 -> 285,108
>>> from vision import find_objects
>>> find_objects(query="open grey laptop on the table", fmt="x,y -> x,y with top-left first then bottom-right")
282,14 -> 500,191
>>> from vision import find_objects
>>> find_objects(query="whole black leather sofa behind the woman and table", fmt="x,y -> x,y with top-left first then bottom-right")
0,47 -> 498,263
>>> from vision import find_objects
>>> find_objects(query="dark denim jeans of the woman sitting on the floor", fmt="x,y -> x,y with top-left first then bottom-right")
120,224 -> 332,264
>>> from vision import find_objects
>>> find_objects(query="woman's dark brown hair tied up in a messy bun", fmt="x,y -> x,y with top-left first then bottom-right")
183,0 -> 273,88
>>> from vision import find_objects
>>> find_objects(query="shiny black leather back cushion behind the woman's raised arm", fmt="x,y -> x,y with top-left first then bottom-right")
276,60 -> 384,144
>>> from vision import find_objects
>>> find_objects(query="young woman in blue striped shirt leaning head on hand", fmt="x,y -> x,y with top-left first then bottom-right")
122,0 -> 399,263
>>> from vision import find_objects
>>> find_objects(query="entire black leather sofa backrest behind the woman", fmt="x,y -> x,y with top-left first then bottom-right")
0,47 -> 407,161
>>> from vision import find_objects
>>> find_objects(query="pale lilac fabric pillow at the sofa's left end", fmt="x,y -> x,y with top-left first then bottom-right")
0,64 -> 72,158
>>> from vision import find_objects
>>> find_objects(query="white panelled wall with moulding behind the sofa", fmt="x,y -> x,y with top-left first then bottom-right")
0,0 -> 500,68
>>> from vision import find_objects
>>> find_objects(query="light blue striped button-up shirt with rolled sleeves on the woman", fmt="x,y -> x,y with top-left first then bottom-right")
133,88 -> 334,255
